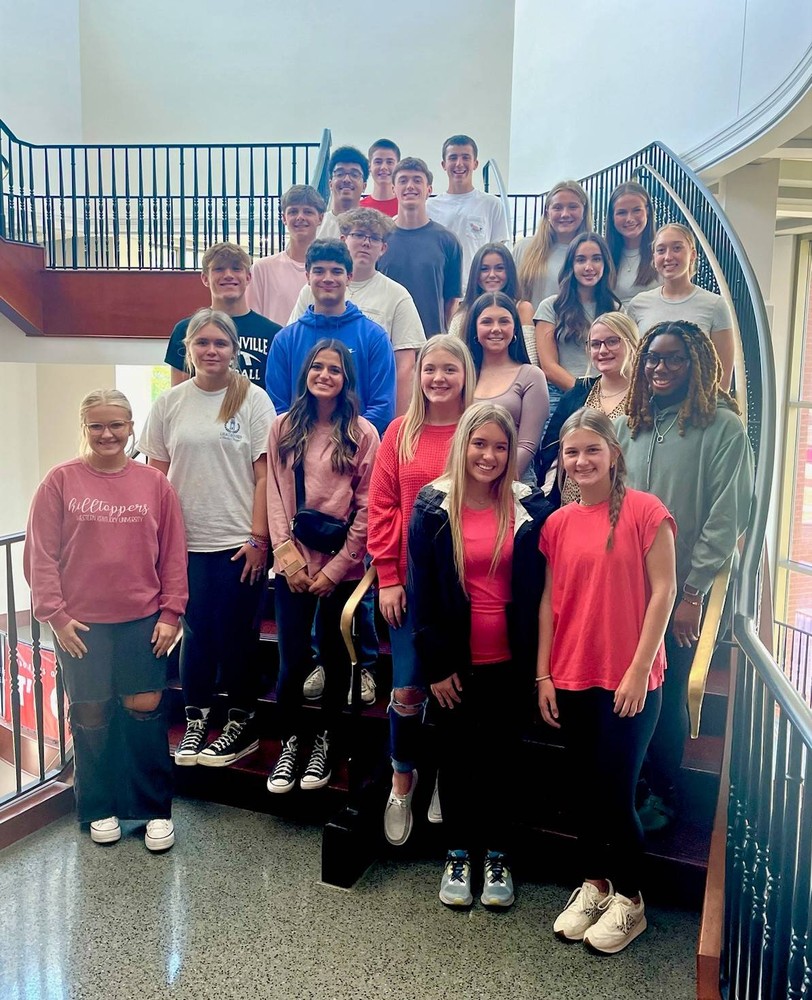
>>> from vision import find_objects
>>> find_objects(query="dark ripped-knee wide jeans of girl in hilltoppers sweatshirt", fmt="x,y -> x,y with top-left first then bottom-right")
55,613 -> 173,823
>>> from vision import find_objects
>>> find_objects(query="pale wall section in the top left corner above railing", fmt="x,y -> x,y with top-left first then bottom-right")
0,0 -> 82,143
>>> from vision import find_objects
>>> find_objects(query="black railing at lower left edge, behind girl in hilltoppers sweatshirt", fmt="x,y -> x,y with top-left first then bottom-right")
0,532 -> 70,804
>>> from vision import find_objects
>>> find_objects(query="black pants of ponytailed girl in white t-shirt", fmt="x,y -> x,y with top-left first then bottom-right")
180,549 -> 264,712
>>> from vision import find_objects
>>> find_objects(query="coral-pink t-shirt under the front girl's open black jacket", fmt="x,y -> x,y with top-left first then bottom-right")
462,507 -> 513,664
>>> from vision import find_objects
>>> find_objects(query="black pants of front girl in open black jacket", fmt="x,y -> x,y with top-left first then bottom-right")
430,661 -> 532,853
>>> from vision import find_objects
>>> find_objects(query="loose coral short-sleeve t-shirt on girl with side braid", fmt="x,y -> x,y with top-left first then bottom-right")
539,490 -> 677,691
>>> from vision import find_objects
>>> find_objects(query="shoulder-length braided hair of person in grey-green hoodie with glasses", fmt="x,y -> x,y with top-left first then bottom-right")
626,319 -> 741,439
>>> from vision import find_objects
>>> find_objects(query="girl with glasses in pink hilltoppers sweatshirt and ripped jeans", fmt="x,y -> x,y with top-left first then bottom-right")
24,389 -> 187,851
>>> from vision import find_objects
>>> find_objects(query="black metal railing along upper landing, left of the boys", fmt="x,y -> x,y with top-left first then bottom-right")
0,122 -> 330,270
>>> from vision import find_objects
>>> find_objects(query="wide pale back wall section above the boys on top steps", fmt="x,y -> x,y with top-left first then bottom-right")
81,0 -> 513,179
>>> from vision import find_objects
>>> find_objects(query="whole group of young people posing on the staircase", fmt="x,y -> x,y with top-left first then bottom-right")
25,129 -> 753,953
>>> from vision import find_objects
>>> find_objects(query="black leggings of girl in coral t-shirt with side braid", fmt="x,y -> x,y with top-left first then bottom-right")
556,688 -> 662,897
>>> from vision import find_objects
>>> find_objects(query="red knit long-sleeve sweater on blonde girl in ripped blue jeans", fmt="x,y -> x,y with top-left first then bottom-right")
367,417 -> 457,587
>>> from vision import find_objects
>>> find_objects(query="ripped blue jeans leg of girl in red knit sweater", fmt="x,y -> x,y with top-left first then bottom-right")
389,610 -> 428,774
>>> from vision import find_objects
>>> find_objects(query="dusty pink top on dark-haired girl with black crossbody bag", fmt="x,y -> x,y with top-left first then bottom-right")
268,414 -> 380,583
